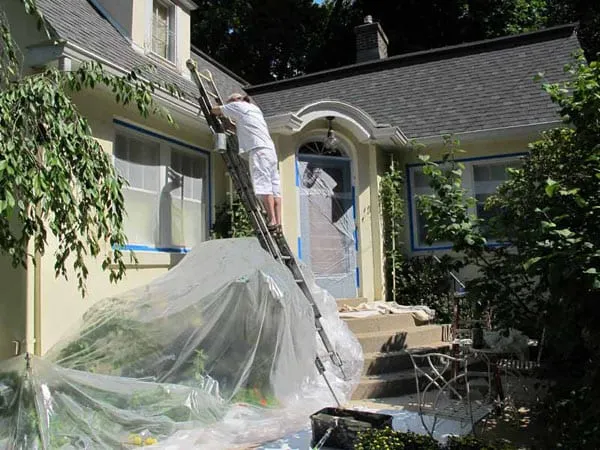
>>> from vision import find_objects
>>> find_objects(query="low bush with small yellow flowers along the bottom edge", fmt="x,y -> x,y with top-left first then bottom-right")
354,428 -> 516,450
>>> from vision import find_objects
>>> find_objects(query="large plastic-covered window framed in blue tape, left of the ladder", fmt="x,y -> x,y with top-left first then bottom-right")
114,129 -> 209,249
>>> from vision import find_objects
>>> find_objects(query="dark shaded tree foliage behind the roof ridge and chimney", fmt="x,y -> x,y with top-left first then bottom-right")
192,0 -> 600,83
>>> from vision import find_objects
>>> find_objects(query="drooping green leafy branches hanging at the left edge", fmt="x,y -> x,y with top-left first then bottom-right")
0,0 -> 182,295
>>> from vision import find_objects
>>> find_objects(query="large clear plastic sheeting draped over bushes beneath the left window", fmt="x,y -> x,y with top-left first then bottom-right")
0,239 -> 363,449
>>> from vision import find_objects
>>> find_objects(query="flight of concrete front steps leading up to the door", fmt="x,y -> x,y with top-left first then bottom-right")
338,302 -> 450,400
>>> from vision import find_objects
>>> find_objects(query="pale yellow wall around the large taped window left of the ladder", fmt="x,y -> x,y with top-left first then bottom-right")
27,91 -> 226,354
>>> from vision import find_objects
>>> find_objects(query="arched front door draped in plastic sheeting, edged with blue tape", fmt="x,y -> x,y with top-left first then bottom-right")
297,140 -> 359,298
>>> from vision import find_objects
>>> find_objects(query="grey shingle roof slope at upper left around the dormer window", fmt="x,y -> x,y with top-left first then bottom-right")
37,0 -> 245,101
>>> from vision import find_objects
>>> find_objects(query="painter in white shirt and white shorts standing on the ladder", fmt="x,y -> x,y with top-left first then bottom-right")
211,93 -> 281,232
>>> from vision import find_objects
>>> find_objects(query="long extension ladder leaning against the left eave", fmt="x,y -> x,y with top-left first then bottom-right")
187,59 -> 346,406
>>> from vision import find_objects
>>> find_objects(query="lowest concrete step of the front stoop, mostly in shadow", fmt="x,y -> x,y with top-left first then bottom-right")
352,369 -> 417,400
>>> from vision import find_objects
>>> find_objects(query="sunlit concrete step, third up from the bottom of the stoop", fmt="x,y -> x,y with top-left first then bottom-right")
355,325 -> 442,353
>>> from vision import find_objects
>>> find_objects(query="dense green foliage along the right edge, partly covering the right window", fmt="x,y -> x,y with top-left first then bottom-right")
420,58 -> 600,448
